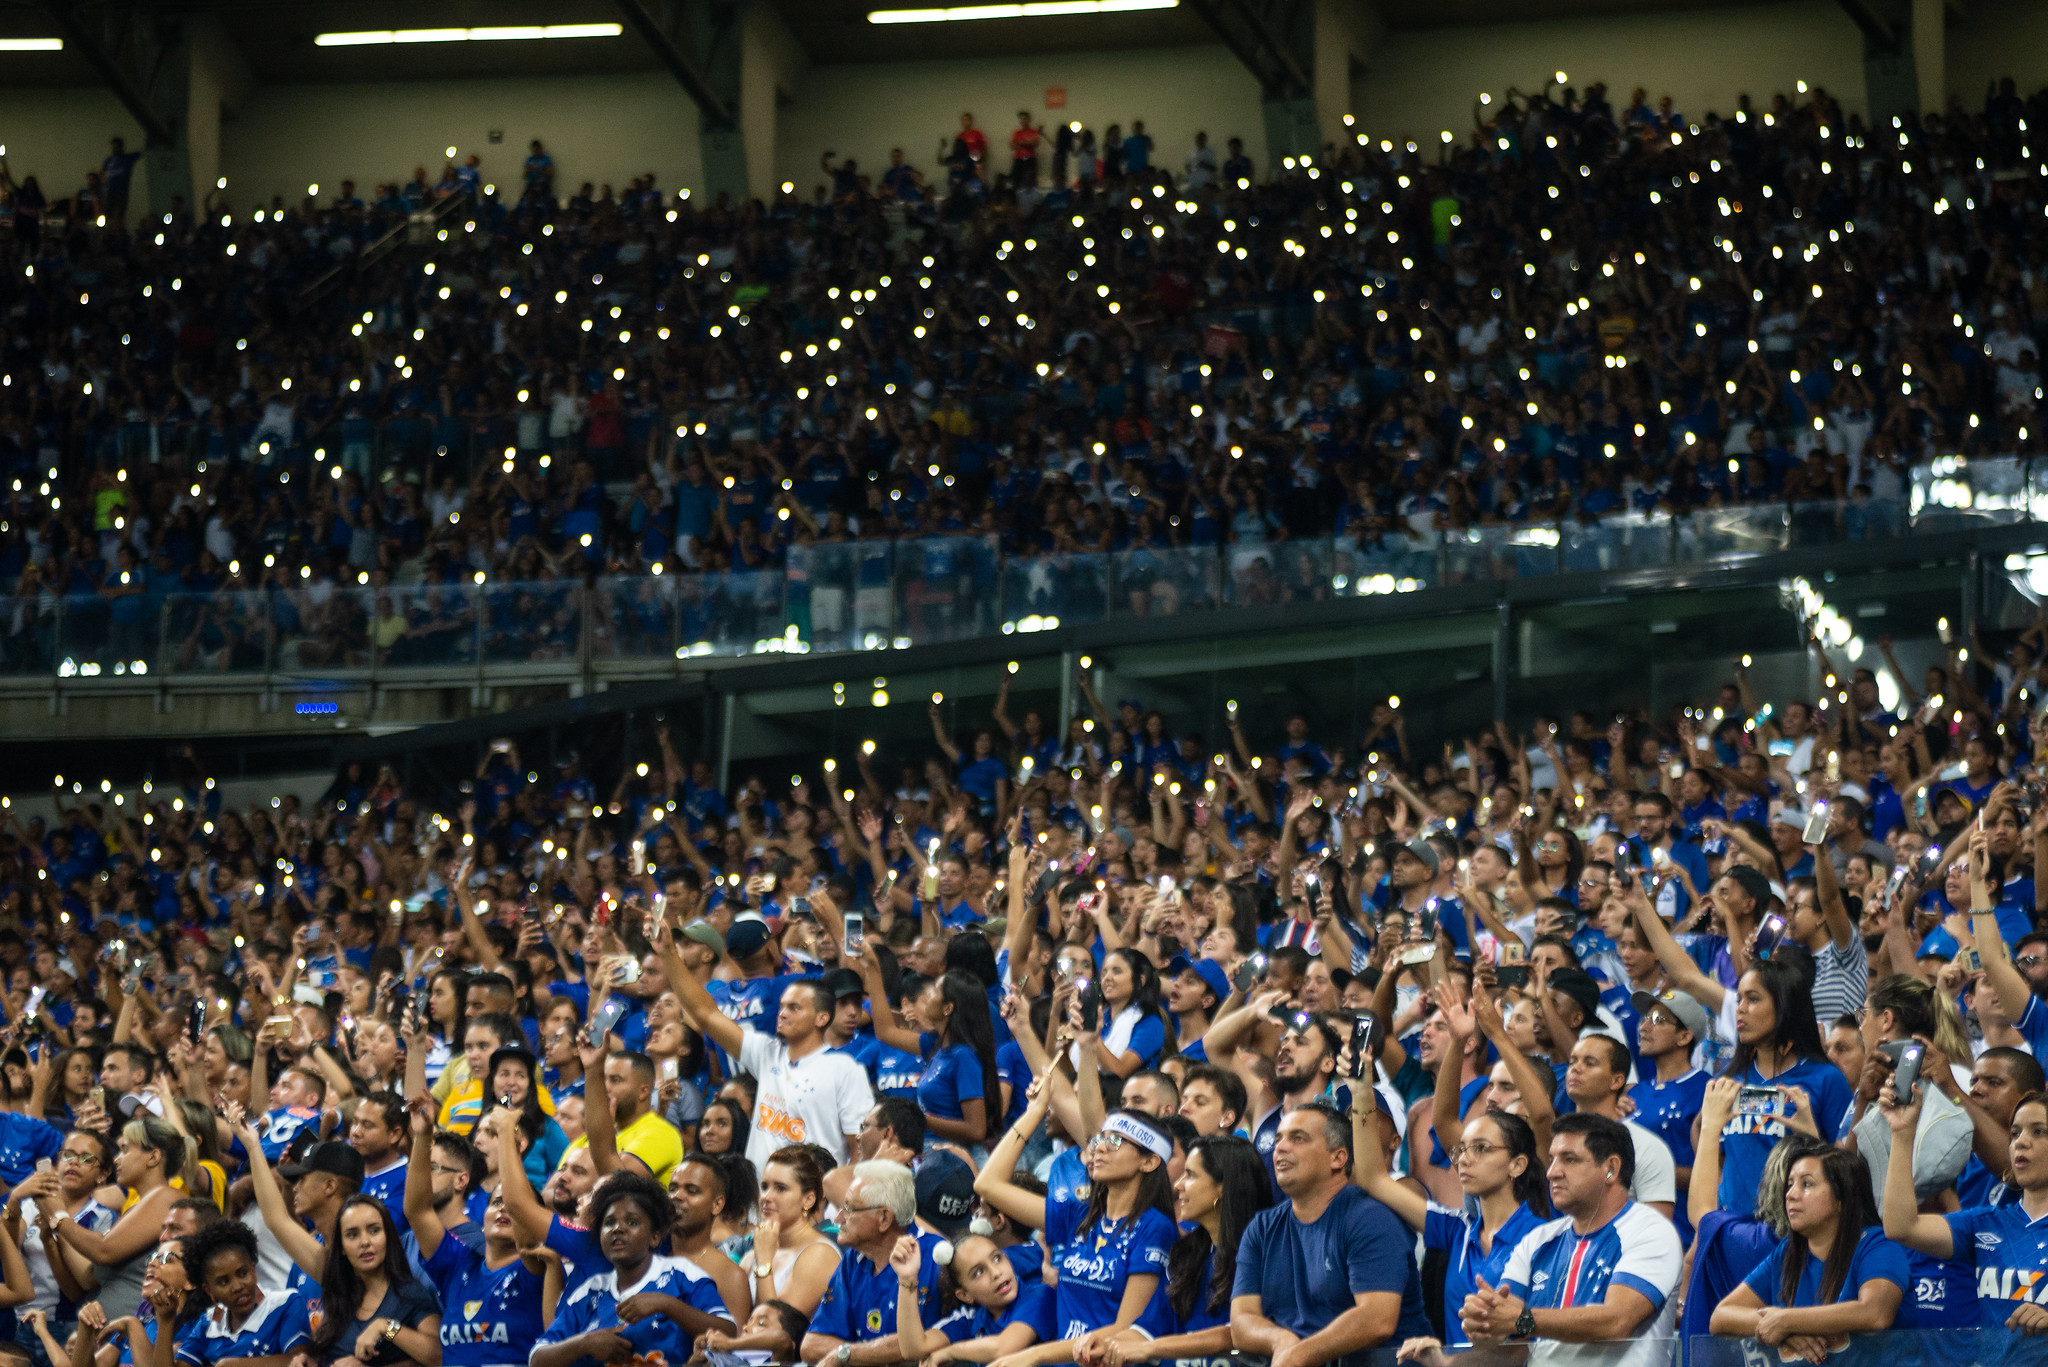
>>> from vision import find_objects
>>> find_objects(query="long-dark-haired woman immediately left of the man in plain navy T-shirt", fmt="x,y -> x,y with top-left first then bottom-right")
1106,1135 -> 1274,1367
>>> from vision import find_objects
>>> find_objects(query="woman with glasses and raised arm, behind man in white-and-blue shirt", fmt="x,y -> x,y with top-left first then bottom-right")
1352,1098 -> 1550,1349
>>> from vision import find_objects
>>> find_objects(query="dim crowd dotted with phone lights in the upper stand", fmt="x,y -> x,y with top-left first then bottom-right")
0,73 -> 2048,658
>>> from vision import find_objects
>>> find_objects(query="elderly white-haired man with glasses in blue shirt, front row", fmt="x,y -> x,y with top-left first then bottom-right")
803,1158 -> 944,1367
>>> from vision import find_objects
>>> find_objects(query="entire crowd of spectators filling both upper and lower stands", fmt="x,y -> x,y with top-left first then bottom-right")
0,64 -> 2048,1367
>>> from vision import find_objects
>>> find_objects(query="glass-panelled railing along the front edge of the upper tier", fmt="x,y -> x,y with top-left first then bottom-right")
0,457 -> 2048,680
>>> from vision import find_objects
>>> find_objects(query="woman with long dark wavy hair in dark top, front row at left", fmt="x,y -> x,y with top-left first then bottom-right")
311,1195 -> 440,1367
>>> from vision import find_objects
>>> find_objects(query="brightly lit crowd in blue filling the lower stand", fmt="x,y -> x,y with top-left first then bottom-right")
0,614 -> 2048,1367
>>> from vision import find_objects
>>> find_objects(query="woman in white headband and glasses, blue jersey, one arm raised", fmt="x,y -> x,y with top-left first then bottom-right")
978,1088 -> 1180,1367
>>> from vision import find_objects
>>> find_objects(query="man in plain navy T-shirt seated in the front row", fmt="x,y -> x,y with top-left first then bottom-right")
1231,1103 -> 1430,1367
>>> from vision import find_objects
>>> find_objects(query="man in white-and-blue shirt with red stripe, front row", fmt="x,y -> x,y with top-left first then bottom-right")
1460,1113 -> 1686,1367
